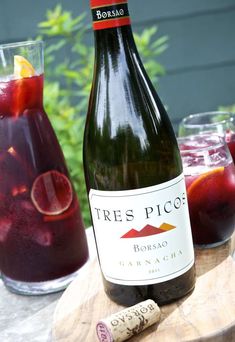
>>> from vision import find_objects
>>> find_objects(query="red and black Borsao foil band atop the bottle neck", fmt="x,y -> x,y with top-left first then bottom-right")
91,0 -> 130,30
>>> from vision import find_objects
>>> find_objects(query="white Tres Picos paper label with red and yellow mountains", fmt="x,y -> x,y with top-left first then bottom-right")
89,174 -> 194,285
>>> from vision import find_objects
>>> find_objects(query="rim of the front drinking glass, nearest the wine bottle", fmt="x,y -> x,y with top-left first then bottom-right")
177,134 -> 226,154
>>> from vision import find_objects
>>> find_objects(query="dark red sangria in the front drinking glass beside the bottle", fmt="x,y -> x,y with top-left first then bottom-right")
185,164 -> 235,245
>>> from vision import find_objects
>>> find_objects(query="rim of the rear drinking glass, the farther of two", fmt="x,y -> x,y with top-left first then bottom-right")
181,111 -> 235,128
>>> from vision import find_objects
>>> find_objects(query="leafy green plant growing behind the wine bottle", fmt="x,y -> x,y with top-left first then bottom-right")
38,5 -> 167,226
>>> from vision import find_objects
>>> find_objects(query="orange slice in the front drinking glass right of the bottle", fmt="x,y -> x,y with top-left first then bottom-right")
187,166 -> 224,197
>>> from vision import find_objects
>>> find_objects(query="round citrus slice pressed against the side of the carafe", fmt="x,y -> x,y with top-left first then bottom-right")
31,170 -> 73,215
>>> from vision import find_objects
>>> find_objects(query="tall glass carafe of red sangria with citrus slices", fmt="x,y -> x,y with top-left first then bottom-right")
0,41 -> 88,294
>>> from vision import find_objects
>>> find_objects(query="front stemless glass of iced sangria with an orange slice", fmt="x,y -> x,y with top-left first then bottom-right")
178,134 -> 235,247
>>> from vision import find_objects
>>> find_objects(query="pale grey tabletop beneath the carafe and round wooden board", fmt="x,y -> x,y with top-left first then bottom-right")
0,228 -> 235,342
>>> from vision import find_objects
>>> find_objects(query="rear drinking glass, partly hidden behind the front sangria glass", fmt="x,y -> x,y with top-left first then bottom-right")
178,111 -> 235,162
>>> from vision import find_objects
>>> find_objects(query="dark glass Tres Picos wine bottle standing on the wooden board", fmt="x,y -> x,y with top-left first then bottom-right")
83,0 -> 195,305
